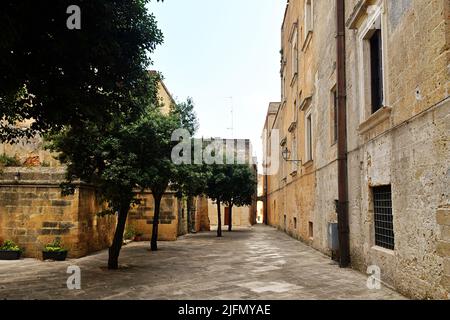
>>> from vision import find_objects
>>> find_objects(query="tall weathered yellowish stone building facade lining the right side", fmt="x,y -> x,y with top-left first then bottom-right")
264,0 -> 450,299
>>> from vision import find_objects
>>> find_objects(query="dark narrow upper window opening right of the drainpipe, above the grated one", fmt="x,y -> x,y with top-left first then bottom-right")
368,29 -> 383,113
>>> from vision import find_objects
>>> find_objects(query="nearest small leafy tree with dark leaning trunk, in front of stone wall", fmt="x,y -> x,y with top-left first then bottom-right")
51,117 -> 140,269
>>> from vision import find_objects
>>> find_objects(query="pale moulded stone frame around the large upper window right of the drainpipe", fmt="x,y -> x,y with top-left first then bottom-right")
356,0 -> 389,124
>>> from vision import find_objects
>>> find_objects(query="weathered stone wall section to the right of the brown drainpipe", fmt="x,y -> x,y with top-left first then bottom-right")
346,0 -> 450,299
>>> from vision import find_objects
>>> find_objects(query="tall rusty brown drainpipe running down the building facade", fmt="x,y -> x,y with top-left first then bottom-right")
336,0 -> 350,268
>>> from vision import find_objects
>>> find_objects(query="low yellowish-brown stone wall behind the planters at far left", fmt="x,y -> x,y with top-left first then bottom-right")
0,167 -> 116,259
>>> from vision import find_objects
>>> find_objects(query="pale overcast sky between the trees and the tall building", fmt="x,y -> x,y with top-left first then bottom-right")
149,0 -> 286,162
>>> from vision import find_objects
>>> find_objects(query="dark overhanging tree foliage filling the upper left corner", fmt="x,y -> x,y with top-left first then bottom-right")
0,0 -> 163,142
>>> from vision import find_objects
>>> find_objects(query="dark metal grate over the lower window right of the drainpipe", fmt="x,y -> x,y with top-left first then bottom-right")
373,185 -> 395,250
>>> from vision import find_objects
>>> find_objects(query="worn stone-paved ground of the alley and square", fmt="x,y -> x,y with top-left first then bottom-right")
0,226 -> 403,300
